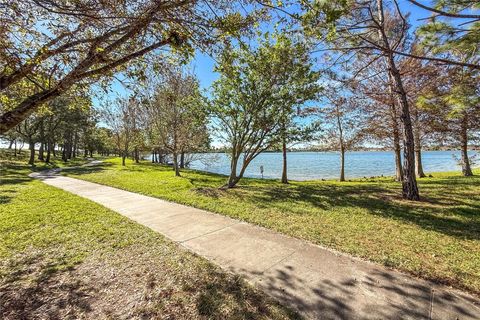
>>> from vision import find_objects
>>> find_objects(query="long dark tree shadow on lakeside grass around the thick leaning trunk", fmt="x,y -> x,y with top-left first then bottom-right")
234,183 -> 480,240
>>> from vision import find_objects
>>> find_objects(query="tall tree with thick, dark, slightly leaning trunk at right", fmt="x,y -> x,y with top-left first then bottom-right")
304,0 -> 420,200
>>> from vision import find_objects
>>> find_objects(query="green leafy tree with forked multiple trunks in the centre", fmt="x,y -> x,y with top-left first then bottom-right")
210,43 -> 285,188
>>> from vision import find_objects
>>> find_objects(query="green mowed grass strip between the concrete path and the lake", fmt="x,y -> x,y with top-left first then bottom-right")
65,159 -> 480,294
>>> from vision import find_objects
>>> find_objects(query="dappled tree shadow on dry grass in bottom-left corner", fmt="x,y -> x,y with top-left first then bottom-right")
0,254 -> 93,320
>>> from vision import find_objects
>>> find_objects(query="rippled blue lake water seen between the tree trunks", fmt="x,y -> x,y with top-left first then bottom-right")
186,151 -> 475,180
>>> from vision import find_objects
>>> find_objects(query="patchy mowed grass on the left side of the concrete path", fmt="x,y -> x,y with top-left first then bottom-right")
0,161 -> 297,319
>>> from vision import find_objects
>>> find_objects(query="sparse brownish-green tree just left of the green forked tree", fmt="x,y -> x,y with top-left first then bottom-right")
146,69 -> 208,176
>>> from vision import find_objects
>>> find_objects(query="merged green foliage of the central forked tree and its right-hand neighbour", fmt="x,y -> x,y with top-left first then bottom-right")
210,32 -> 320,158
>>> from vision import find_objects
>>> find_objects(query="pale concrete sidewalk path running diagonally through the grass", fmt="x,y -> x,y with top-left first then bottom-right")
32,172 -> 480,319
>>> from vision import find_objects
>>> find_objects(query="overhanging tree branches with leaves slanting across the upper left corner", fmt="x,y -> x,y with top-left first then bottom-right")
0,0 -> 256,134
